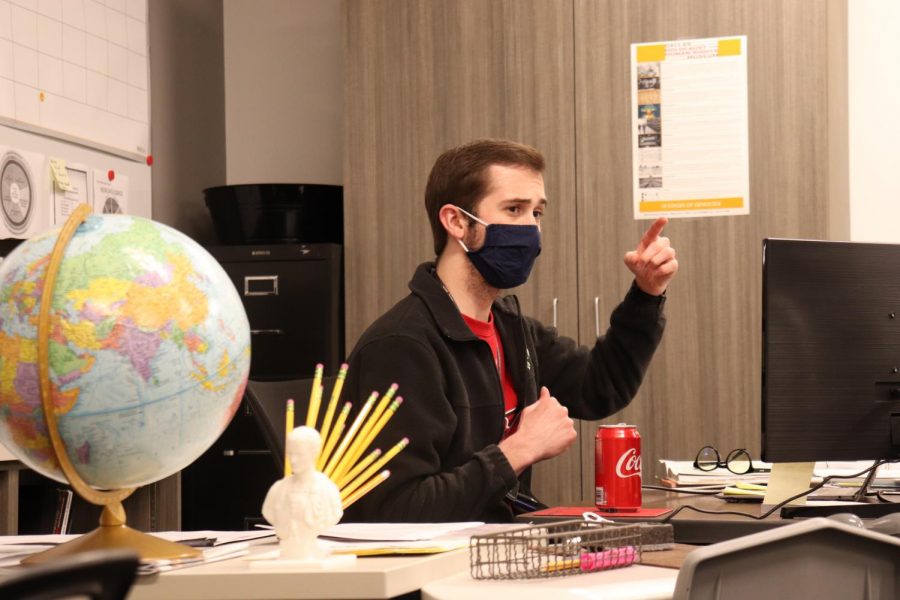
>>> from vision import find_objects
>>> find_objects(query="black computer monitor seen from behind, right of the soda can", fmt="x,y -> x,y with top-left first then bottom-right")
762,239 -> 900,462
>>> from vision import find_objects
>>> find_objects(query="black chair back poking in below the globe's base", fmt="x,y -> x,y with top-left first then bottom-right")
0,550 -> 139,600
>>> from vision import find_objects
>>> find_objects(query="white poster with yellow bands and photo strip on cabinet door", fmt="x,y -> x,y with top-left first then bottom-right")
631,36 -> 750,219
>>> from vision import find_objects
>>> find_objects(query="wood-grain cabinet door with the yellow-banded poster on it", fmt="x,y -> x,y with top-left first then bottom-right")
574,0 -> 846,501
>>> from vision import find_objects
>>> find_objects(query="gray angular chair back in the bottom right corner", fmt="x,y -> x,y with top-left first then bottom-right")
673,517 -> 900,600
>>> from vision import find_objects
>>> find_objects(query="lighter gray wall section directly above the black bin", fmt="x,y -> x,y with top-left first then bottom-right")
224,0 -> 343,185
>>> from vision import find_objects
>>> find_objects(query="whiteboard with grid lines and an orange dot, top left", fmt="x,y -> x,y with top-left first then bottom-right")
0,0 -> 150,161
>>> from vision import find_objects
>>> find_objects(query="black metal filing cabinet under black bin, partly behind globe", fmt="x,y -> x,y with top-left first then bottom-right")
182,243 -> 344,530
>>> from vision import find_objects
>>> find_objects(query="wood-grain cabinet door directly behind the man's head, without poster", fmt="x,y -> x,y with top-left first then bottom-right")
343,0 -> 581,503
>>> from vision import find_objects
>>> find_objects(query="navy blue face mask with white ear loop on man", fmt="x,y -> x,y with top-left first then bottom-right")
456,206 -> 541,290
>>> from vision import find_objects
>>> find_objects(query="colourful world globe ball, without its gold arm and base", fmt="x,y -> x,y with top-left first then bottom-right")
0,215 -> 250,489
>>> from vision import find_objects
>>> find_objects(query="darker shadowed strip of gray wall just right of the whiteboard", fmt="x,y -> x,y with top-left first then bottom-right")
149,0 -> 225,243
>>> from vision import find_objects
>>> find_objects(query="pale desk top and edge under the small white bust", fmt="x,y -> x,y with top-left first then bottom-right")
128,544 -> 474,600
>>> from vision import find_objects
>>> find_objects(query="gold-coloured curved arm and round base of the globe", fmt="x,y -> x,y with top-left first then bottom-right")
22,204 -> 200,564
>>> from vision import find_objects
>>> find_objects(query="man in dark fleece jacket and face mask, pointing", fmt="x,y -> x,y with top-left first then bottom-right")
344,140 -> 678,522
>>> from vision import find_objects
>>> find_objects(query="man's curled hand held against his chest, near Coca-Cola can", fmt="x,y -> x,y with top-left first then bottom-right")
500,387 -> 578,474
